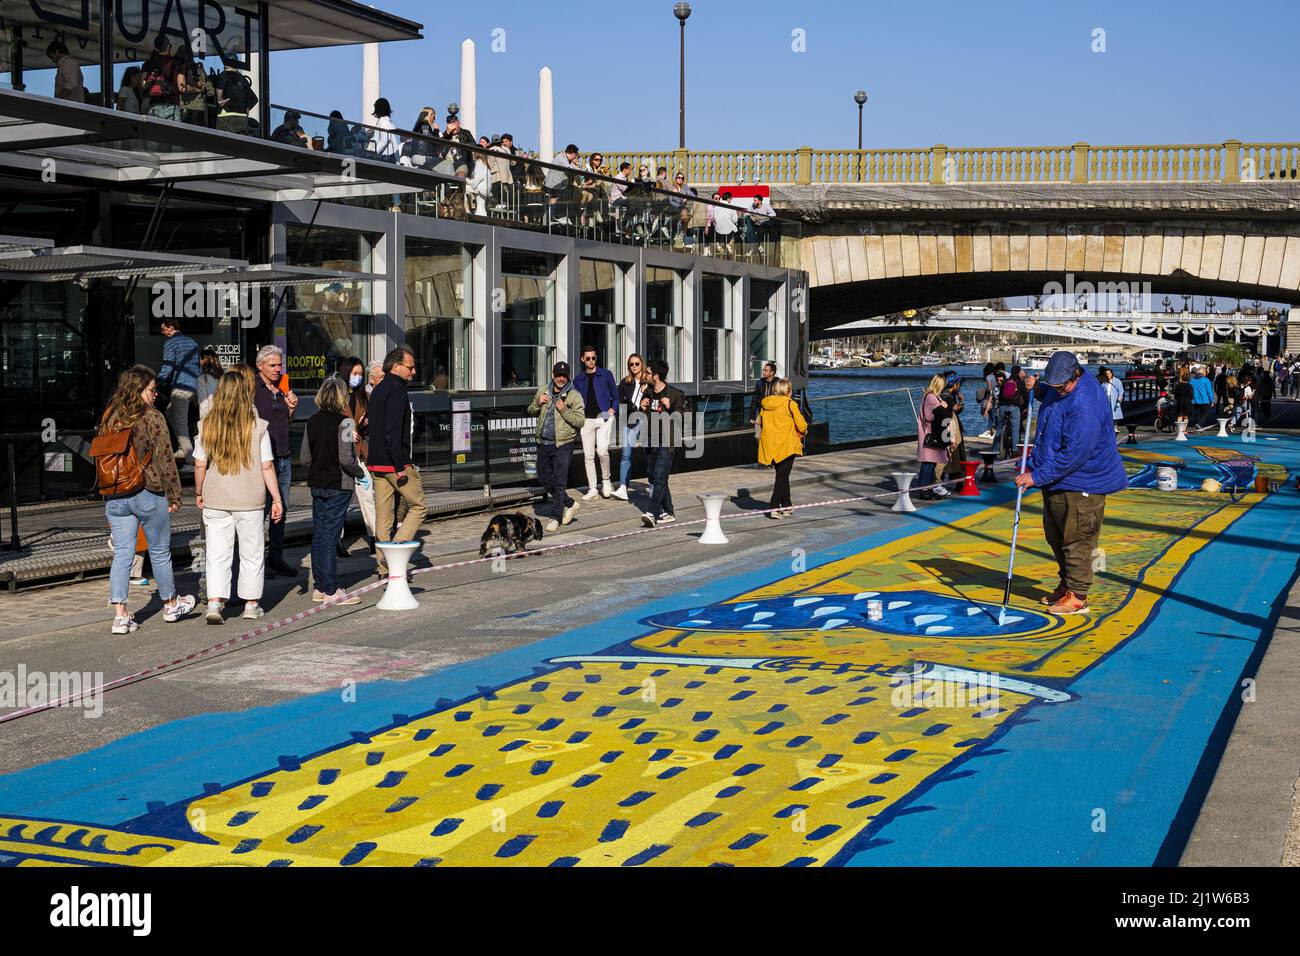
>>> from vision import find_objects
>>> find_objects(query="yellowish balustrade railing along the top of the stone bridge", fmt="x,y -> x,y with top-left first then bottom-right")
592,139 -> 1300,186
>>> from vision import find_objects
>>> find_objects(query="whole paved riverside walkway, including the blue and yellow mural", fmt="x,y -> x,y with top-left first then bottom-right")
0,436 -> 1300,865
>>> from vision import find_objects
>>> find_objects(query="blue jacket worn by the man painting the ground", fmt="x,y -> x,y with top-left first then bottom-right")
1030,375 -> 1128,494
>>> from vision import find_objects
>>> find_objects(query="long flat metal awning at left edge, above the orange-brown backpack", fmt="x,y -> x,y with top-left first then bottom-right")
0,246 -> 248,282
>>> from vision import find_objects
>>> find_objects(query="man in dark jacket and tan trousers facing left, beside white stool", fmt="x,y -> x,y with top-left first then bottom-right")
365,346 -> 428,576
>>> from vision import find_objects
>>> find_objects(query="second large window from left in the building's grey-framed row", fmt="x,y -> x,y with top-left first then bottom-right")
406,238 -> 473,389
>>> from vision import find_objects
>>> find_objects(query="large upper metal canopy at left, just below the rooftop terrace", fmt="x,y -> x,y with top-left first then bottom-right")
0,90 -> 460,202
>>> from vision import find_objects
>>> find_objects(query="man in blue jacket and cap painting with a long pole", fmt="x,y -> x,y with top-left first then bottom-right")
1015,351 -> 1128,614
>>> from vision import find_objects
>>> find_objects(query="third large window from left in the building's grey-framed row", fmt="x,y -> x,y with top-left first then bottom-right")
501,250 -> 559,389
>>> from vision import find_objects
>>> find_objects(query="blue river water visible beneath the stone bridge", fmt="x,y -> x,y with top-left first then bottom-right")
807,364 -> 1128,444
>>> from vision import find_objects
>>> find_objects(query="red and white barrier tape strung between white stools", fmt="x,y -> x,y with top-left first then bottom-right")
0,462 -> 993,723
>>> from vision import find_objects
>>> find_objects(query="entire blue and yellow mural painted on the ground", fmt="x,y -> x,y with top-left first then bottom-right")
0,440 -> 1300,866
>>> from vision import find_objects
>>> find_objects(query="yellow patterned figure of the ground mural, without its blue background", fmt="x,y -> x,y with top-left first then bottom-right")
0,445 -> 1295,866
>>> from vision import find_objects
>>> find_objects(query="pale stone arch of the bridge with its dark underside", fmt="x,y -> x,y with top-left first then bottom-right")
801,220 -> 1300,334
